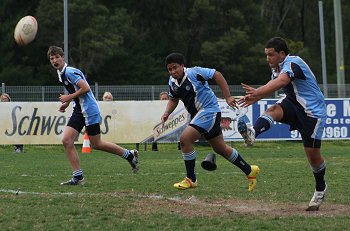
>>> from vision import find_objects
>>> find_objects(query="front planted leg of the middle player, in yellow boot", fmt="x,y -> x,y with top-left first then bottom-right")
174,126 -> 201,189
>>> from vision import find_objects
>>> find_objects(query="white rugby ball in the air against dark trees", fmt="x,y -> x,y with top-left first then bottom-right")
14,16 -> 38,46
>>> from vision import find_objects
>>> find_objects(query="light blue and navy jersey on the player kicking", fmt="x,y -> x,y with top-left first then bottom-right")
272,55 -> 326,119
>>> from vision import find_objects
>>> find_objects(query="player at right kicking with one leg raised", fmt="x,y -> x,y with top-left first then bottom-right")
238,37 -> 327,211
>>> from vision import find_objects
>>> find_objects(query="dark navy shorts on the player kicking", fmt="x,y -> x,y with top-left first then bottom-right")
277,98 -> 321,148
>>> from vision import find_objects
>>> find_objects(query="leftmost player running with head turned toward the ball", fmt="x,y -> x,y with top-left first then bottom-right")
47,46 -> 139,185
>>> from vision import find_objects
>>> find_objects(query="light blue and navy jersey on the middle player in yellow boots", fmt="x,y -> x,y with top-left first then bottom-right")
169,67 -> 220,118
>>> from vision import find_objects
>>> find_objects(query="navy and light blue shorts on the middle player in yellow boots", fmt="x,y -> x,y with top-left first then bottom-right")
189,112 -> 222,140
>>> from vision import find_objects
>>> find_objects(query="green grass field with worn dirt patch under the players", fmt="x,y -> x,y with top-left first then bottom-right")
0,141 -> 350,231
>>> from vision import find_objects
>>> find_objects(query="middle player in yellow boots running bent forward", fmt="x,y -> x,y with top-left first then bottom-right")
161,53 -> 260,191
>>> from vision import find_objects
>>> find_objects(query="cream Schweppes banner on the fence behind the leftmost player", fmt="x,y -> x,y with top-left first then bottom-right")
0,100 -> 168,144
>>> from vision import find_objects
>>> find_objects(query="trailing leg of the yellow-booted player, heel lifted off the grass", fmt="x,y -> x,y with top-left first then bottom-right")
208,133 -> 260,192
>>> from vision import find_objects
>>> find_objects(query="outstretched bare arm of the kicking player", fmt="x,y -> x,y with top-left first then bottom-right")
238,73 -> 291,107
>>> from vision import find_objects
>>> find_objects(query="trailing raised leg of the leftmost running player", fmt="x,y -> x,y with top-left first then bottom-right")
86,123 -> 139,173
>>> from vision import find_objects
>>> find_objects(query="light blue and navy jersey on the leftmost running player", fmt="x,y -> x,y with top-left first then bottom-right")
57,64 -> 101,126
